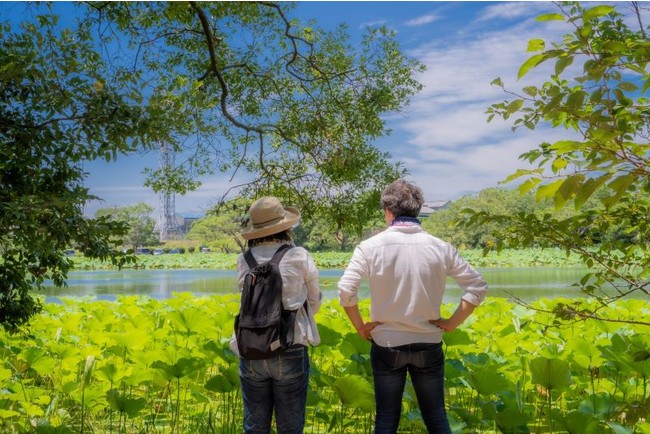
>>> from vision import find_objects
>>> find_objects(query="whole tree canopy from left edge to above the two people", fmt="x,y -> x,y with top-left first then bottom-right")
0,2 -> 422,329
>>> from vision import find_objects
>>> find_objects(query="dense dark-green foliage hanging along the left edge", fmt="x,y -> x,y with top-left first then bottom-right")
0,6 -> 148,330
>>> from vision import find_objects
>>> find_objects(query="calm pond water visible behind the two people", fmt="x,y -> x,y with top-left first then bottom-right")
42,268 -> 604,303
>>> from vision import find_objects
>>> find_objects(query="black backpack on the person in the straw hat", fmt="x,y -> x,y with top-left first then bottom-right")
235,244 -> 300,360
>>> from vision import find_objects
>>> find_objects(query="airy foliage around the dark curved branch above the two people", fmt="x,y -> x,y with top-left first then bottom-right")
87,2 -> 423,239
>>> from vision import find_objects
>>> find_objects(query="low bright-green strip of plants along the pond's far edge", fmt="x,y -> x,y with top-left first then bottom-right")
70,248 -> 584,270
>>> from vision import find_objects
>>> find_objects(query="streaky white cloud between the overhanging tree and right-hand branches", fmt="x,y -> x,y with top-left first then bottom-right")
384,4 -> 566,200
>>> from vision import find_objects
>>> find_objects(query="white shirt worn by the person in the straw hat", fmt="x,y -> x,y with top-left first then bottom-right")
237,243 -> 322,345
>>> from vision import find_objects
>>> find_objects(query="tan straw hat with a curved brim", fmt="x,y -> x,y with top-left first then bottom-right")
242,196 -> 300,240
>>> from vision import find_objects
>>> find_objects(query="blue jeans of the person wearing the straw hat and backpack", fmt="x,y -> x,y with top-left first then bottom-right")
239,345 -> 309,434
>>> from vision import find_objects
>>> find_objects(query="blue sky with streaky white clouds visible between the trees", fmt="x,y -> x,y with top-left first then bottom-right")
5,1 -> 632,215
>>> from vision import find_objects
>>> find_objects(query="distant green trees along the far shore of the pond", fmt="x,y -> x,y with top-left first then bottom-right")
91,187 -> 650,256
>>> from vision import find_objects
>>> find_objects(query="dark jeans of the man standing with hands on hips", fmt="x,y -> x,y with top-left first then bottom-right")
370,342 -> 451,434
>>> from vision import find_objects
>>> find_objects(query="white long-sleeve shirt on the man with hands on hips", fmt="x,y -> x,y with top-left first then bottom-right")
338,224 -> 487,347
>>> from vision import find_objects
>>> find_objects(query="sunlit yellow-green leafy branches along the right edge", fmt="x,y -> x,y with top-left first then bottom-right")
478,3 -> 650,305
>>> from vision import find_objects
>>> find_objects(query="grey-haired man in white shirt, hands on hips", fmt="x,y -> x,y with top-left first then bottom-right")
338,179 -> 487,434
